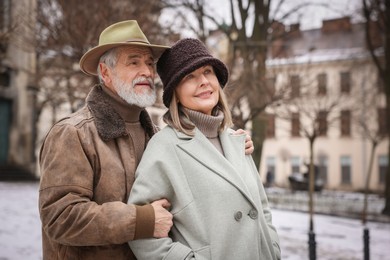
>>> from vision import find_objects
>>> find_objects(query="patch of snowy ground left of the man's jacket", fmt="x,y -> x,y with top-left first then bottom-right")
0,182 -> 42,260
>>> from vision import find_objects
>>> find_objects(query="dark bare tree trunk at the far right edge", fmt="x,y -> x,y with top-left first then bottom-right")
362,0 -> 390,215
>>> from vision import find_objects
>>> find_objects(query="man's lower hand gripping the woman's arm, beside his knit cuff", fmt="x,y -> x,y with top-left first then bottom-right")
151,199 -> 173,238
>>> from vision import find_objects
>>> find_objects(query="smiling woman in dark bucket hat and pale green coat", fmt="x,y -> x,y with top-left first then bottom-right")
129,39 -> 280,260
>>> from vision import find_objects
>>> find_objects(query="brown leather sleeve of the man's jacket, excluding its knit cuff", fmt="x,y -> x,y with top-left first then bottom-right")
39,125 -> 154,246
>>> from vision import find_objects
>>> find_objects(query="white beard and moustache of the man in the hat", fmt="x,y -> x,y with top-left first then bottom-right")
112,73 -> 157,107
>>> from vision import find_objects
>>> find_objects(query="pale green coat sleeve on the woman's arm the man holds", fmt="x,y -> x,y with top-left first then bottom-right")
128,134 -> 206,260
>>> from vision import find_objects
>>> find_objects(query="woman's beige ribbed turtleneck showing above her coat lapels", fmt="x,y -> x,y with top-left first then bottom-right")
186,109 -> 224,155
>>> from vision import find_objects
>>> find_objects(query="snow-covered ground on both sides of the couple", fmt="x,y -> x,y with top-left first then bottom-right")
0,182 -> 390,260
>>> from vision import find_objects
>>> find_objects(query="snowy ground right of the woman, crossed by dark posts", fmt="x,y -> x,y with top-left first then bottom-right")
272,210 -> 390,260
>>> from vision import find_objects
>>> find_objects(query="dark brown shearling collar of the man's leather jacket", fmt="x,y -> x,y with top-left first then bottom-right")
86,85 -> 157,141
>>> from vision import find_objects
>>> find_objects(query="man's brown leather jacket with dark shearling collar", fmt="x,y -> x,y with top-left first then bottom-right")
39,86 -> 156,260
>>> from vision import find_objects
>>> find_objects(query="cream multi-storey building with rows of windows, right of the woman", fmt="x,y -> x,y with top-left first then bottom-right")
259,17 -> 388,192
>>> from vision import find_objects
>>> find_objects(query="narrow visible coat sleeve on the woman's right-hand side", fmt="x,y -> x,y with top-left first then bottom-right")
245,155 -> 281,259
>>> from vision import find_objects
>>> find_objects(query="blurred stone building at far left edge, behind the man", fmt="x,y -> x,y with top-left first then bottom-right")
0,0 -> 36,175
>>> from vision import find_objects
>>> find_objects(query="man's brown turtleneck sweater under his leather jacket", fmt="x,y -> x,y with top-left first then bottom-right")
102,86 -> 146,166
